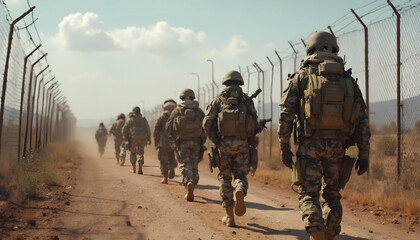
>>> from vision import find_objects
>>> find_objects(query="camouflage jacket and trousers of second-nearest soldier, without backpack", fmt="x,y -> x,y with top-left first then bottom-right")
203,85 -> 258,207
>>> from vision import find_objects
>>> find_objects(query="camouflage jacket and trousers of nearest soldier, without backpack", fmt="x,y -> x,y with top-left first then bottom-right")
278,51 -> 370,236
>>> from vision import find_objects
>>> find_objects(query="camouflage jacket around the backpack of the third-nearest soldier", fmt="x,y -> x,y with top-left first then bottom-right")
165,101 -> 207,144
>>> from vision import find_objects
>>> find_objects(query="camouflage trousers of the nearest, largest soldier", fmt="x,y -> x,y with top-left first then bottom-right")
297,139 -> 345,235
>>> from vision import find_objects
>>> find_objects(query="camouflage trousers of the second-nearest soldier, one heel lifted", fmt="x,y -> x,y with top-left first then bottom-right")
217,137 -> 249,207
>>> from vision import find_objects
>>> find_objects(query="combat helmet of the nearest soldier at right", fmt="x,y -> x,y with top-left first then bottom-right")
306,31 -> 340,55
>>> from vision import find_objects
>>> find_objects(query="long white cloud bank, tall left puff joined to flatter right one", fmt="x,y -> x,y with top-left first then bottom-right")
50,12 -> 205,56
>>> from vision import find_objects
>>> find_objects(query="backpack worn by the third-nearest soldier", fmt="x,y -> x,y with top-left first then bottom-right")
174,108 -> 202,140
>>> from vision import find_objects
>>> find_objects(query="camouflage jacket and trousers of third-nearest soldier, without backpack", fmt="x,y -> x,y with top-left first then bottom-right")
166,99 -> 207,186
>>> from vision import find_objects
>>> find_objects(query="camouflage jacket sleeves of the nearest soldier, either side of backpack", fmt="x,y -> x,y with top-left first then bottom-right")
278,63 -> 370,156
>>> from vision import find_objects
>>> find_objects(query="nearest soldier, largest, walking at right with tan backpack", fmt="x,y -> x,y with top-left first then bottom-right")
278,32 -> 370,240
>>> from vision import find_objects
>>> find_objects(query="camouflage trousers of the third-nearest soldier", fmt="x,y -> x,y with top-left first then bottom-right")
176,140 -> 201,186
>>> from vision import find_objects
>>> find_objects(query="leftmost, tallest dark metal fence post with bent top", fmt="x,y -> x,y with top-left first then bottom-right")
0,7 -> 35,153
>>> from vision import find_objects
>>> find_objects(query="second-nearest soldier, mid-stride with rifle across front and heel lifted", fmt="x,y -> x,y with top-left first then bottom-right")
203,71 -> 260,227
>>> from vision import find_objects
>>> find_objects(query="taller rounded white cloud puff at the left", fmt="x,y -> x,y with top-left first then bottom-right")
51,12 -> 116,51
